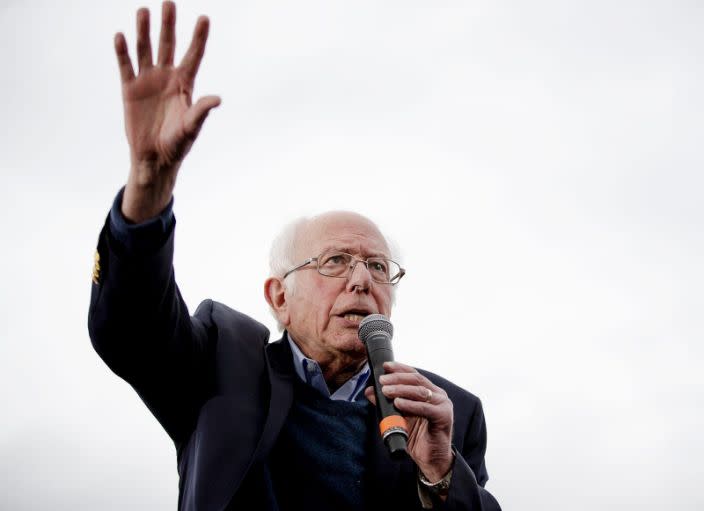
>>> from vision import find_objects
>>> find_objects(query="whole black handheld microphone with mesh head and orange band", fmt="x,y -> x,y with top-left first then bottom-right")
359,314 -> 408,459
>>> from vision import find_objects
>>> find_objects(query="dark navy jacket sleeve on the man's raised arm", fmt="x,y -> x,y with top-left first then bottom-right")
88,212 -> 213,447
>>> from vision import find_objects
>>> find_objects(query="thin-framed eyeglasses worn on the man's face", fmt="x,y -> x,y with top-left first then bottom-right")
283,250 -> 406,285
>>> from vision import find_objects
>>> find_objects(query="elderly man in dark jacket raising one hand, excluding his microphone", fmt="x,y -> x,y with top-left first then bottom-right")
89,2 -> 499,510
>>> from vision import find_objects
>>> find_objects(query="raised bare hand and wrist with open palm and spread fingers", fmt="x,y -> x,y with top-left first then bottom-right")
115,2 -> 220,222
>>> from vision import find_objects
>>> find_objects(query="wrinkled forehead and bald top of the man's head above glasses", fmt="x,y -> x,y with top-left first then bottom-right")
296,212 -> 391,258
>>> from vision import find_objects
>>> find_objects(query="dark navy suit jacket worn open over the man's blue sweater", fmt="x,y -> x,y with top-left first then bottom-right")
88,218 -> 499,511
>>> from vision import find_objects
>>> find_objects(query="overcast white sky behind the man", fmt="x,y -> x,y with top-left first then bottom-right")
0,0 -> 704,511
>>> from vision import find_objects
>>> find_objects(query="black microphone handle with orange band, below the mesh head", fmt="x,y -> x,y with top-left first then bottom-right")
365,332 -> 408,458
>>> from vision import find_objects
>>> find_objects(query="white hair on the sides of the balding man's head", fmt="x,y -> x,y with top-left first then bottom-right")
269,213 -> 401,331
